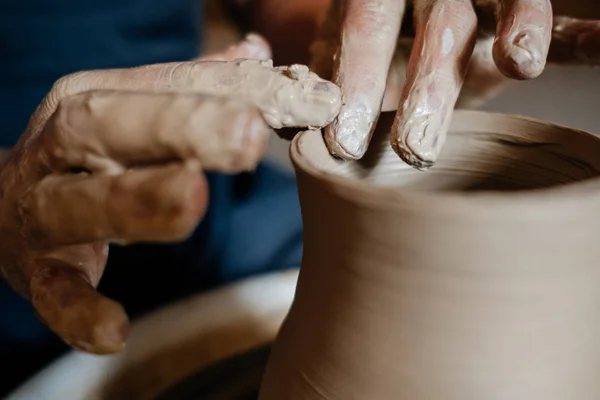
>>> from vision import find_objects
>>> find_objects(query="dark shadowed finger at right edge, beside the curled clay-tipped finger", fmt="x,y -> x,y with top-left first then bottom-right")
548,17 -> 600,66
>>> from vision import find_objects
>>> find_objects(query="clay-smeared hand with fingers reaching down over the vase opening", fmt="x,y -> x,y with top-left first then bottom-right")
315,0 -> 596,168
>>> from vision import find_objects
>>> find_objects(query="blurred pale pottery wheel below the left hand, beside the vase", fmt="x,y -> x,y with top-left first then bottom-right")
5,270 -> 298,400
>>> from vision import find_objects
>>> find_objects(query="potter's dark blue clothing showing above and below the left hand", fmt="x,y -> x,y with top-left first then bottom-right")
0,0 -> 302,397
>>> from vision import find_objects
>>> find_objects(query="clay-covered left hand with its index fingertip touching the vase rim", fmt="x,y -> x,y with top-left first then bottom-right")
0,38 -> 340,353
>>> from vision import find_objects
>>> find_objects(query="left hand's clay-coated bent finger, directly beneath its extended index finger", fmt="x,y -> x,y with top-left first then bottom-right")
41,91 -> 271,174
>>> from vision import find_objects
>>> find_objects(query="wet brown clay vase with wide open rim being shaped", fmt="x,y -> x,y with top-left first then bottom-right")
260,111 -> 600,400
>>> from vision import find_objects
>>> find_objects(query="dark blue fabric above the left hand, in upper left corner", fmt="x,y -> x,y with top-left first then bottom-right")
0,0 -> 202,146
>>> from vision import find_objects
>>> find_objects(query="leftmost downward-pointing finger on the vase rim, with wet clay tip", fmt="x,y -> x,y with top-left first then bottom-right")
325,0 -> 405,159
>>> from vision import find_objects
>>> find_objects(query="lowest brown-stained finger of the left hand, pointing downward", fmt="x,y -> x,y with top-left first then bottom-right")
30,253 -> 129,354
